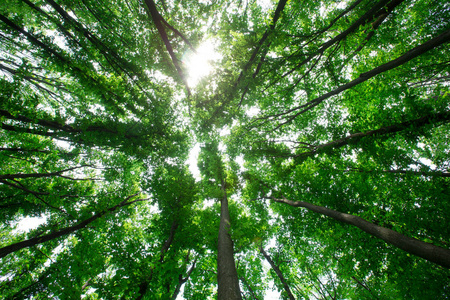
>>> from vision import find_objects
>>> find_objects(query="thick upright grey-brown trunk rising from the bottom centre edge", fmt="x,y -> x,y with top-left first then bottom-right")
217,180 -> 242,300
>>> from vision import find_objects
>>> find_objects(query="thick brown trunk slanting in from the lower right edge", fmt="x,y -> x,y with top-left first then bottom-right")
270,197 -> 450,268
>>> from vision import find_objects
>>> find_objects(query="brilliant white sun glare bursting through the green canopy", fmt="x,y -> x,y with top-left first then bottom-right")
184,41 -> 221,87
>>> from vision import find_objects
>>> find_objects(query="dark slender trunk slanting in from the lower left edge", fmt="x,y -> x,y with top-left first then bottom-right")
0,196 -> 147,258
